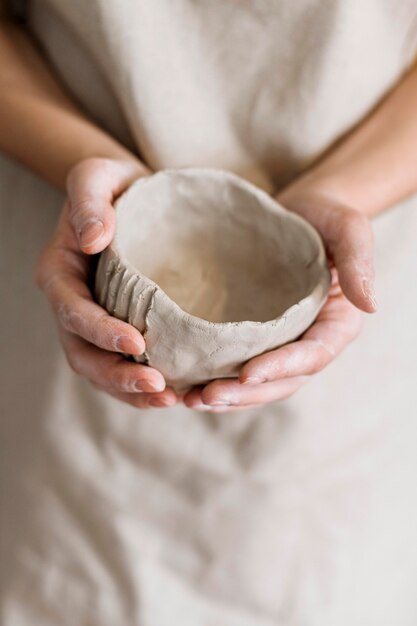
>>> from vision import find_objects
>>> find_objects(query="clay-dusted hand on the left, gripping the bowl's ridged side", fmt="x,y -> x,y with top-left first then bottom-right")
36,158 -> 178,408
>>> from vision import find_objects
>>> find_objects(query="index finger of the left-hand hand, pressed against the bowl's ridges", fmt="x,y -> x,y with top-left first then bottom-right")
41,271 -> 145,355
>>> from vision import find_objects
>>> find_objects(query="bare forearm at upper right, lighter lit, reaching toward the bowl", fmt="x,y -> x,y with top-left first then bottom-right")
282,61 -> 417,217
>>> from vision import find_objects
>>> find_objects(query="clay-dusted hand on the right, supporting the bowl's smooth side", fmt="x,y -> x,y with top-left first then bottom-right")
184,183 -> 376,412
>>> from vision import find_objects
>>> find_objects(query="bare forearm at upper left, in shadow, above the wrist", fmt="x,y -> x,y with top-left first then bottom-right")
0,18 -> 138,188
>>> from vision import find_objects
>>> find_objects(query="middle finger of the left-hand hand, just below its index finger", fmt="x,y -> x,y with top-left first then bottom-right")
61,331 -> 167,395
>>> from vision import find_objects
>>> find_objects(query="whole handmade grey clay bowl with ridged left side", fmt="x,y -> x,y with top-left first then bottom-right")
95,168 -> 330,391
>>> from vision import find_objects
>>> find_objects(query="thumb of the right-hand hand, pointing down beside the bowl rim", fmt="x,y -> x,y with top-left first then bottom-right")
327,209 -> 377,313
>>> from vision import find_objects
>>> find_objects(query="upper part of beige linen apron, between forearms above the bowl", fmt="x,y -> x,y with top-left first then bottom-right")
24,0 -> 417,189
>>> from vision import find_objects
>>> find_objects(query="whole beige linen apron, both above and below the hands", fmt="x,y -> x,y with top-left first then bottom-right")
0,0 -> 417,626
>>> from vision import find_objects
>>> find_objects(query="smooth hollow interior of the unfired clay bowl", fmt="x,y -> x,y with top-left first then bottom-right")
114,170 -> 323,322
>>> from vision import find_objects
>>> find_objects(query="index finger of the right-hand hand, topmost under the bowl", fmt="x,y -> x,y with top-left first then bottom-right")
239,286 -> 361,385
